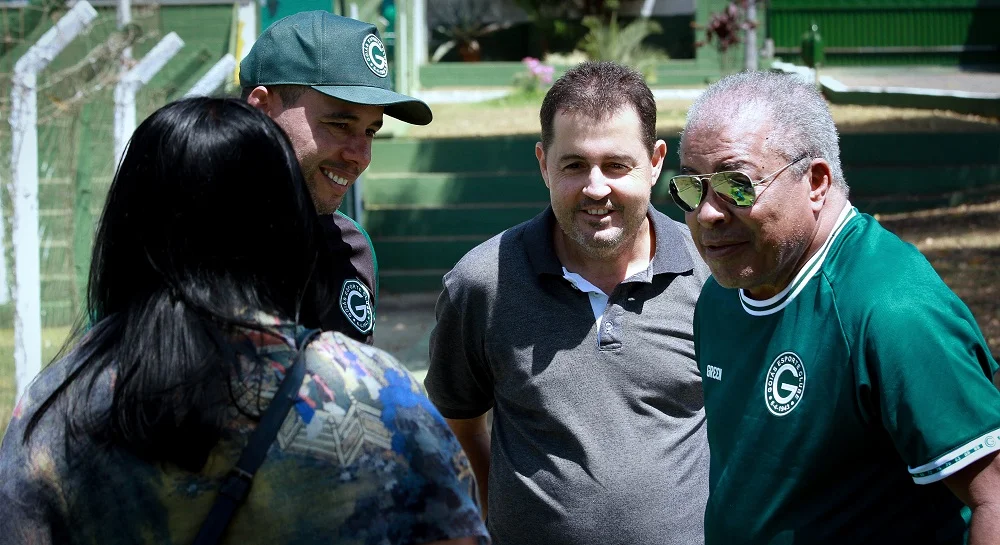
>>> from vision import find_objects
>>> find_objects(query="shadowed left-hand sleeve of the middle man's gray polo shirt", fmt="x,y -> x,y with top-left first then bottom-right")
424,271 -> 494,419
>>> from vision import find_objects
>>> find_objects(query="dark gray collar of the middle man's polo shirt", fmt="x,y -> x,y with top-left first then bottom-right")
524,205 -> 694,282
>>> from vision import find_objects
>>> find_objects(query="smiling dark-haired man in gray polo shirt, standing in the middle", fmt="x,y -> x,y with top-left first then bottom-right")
425,63 -> 709,545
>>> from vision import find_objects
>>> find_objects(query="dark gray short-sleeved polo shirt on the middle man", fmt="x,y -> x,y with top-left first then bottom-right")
425,207 -> 709,545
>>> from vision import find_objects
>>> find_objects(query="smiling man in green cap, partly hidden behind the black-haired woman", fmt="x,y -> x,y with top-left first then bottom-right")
240,11 -> 431,343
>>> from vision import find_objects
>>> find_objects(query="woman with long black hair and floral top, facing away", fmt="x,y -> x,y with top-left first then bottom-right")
0,98 -> 487,544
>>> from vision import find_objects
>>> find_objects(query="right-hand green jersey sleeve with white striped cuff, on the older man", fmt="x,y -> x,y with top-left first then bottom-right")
860,281 -> 1000,484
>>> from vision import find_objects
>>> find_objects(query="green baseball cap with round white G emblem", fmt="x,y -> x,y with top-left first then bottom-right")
240,11 -> 433,125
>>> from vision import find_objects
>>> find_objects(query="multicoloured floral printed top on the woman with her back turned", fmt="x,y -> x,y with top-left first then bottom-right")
0,317 -> 489,545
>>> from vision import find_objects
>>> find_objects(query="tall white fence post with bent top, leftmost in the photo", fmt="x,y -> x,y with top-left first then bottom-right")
10,0 -> 97,399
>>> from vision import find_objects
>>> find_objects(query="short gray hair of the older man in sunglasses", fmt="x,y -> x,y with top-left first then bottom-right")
678,72 -> 848,195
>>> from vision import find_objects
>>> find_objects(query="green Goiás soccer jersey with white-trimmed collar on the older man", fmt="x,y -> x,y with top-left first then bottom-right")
695,205 -> 1000,545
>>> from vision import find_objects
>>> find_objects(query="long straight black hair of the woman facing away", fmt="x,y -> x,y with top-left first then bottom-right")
24,98 -> 335,470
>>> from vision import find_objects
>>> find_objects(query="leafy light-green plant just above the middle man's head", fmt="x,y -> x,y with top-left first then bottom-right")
577,12 -> 668,83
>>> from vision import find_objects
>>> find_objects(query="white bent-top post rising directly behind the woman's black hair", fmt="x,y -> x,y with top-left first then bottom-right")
115,32 -> 184,166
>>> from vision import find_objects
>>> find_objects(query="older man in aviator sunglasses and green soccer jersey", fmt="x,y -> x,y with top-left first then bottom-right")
669,72 -> 1000,545
